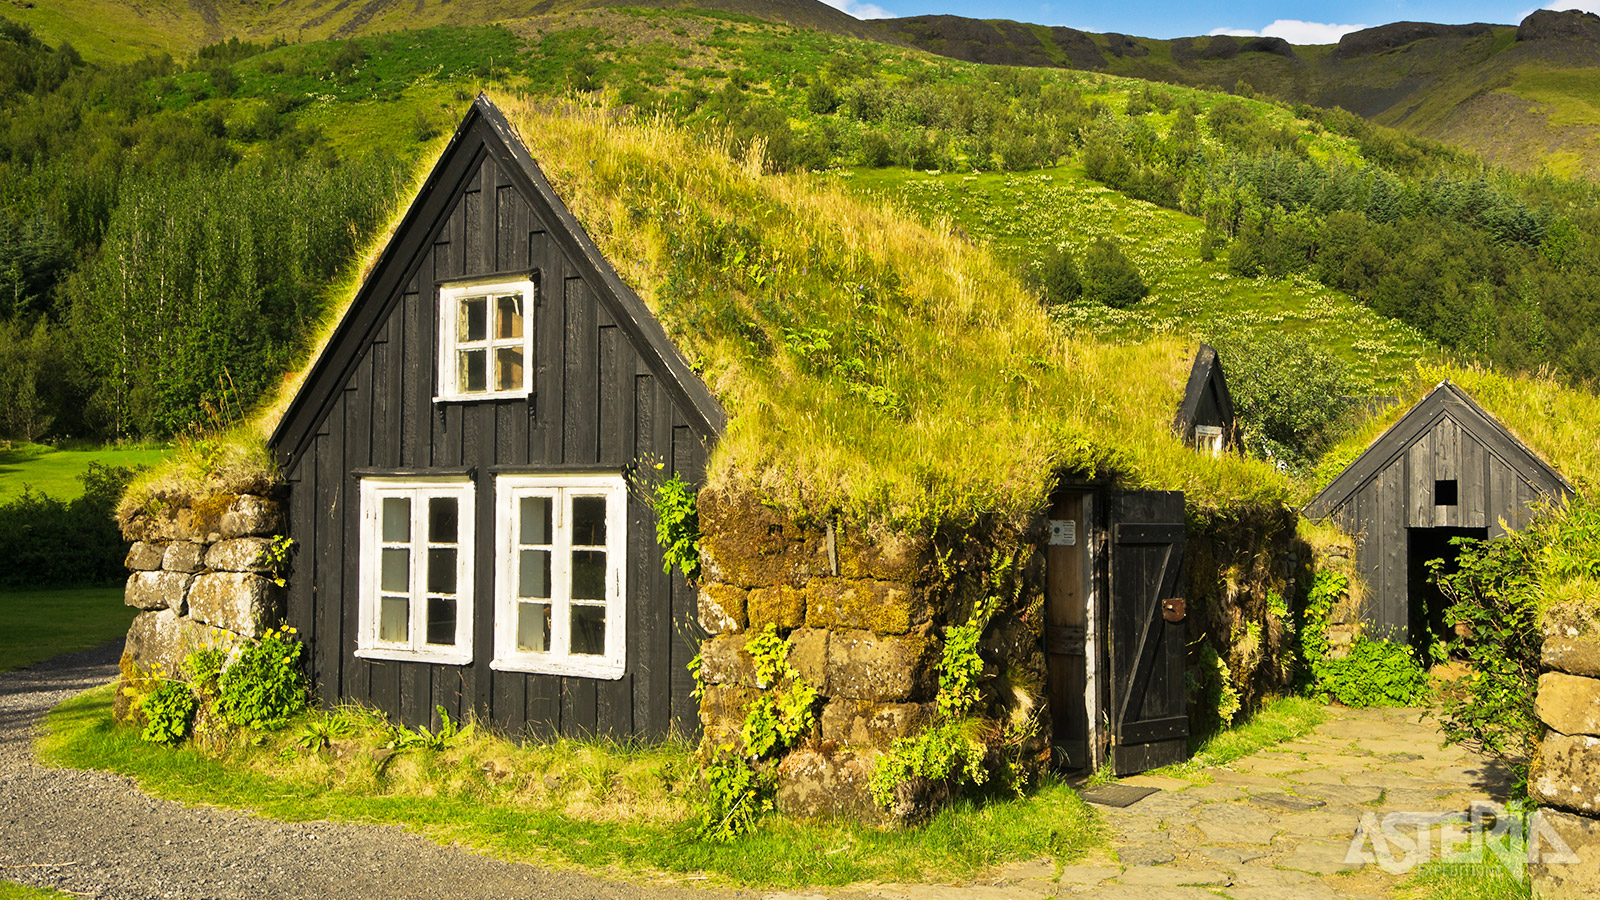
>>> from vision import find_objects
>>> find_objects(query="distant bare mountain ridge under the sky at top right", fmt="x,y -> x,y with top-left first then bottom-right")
877,10 -> 1600,179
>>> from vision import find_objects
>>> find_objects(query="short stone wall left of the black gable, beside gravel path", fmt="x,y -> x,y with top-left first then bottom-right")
117,493 -> 283,717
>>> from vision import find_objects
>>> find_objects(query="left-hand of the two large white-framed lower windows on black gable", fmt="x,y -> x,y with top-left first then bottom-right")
355,477 -> 474,665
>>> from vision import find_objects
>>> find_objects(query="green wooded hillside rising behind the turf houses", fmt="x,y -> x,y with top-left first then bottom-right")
0,5 -> 1600,483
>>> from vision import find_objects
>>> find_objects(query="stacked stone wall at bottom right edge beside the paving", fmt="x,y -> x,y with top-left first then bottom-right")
1528,610 -> 1600,900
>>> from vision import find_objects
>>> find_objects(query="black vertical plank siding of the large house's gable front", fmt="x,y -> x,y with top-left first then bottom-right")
288,131 -> 710,738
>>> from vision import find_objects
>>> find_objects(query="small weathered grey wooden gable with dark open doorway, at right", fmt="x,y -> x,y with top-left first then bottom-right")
1306,381 -> 1573,642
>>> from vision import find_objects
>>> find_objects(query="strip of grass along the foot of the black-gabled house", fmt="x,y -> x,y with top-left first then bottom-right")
38,687 -> 1104,887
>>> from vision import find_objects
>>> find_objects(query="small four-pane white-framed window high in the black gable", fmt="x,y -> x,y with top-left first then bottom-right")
437,279 -> 536,400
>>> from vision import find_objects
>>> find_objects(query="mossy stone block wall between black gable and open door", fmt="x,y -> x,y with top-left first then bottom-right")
699,490 -> 1050,820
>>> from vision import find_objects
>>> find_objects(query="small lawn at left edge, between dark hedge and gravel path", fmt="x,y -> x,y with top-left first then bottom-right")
0,585 -> 136,673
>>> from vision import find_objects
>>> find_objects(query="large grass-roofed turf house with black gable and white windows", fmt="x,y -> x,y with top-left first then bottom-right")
122,96 -> 1312,817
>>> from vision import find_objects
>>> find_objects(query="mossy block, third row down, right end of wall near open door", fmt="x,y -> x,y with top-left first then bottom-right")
827,629 -> 939,703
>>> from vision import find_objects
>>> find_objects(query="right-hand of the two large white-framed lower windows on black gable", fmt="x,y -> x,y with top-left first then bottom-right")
491,474 -> 627,679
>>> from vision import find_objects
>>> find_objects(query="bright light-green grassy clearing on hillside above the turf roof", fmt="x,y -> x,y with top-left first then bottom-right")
845,167 -> 1440,392
